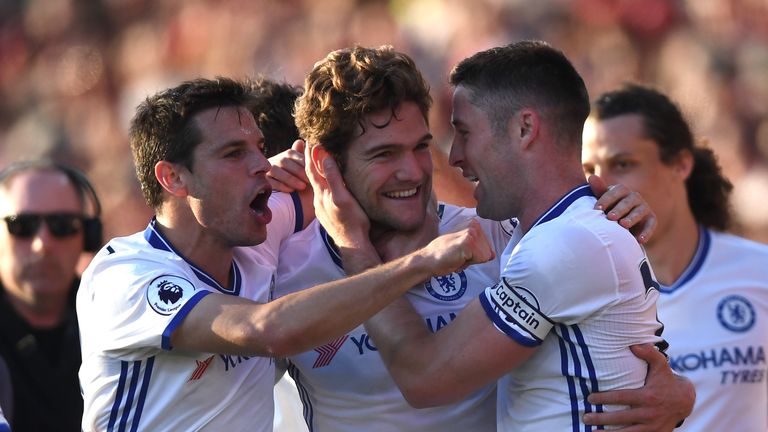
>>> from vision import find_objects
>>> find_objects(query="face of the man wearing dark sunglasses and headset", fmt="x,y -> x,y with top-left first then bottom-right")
0,170 -> 83,305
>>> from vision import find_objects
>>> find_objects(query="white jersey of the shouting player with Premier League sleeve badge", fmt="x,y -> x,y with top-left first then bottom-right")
77,194 -> 301,432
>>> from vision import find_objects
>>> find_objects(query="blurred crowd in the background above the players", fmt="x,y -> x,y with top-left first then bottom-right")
0,0 -> 768,242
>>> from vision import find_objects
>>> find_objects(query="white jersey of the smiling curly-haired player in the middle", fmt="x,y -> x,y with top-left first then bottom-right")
276,205 -> 516,432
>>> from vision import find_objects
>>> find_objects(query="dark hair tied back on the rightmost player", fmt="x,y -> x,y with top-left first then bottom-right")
595,83 -> 733,231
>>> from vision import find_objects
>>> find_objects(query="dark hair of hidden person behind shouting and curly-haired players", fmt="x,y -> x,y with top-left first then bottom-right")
245,75 -> 304,157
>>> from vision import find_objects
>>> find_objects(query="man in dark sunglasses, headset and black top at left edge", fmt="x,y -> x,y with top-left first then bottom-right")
0,160 -> 97,431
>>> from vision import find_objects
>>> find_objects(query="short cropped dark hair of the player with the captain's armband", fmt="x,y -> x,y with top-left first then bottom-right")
449,41 -> 590,145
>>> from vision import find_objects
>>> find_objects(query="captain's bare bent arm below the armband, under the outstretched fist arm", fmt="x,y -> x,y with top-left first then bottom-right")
365,298 -> 536,408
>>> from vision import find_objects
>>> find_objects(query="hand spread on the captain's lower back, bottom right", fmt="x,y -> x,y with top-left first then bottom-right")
584,344 -> 696,432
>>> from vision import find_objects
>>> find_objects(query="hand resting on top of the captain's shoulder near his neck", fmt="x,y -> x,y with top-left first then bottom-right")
587,174 -> 657,244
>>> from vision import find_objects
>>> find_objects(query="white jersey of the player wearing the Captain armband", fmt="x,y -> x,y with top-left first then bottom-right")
480,185 -> 663,432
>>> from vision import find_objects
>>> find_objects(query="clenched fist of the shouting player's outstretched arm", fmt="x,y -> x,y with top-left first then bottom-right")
419,220 -> 496,275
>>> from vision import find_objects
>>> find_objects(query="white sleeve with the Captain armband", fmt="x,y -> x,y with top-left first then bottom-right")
480,224 -> 617,346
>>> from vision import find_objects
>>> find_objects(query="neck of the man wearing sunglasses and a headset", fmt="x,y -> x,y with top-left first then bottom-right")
6,287 -> 69,329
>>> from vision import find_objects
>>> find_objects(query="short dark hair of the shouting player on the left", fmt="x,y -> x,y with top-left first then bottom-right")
130,77 -> 250,209
